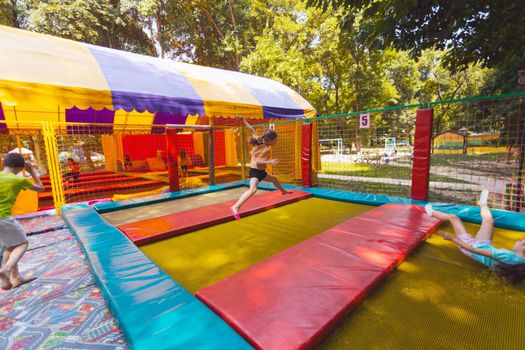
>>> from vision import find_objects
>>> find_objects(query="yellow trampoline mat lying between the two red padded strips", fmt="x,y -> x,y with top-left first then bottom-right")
140,198 -> 372,292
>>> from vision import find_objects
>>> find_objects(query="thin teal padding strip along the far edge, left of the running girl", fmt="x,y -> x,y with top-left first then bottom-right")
94,181 -> 244,213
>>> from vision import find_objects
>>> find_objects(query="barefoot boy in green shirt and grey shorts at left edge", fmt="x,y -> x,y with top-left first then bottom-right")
0,153 -> 45,290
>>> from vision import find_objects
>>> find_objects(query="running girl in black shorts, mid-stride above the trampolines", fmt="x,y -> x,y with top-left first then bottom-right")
231,117 -> 291,220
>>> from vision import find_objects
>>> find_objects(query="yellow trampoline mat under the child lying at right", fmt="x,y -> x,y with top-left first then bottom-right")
320,219 -> 525,350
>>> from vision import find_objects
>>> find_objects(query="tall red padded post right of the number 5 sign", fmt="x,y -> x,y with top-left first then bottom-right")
410,108 -> 434,201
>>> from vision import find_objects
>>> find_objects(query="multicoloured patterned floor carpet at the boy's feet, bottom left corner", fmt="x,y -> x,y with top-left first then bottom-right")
0,216 -> 128,350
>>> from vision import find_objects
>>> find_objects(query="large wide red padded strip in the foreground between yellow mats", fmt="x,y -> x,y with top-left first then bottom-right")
196,204 -> 439,350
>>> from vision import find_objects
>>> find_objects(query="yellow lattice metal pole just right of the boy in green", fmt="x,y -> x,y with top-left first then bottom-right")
42,122 -> 65,214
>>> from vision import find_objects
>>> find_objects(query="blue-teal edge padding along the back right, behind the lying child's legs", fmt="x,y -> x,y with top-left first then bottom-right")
297,187 -> 525,232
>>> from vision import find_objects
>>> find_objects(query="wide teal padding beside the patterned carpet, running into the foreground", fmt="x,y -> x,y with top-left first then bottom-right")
62,205 -> 252,349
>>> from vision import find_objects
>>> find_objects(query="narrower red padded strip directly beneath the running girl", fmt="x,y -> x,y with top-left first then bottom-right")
118,191 -> 312,246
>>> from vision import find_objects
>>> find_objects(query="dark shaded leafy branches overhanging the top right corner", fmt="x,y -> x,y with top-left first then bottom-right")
309,0 -> 525,91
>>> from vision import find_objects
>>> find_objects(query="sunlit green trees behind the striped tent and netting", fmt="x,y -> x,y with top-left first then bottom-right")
0,0 -> 500,119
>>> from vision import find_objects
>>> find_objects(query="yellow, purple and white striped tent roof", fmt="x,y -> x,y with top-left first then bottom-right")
0,26 -> 316,131
